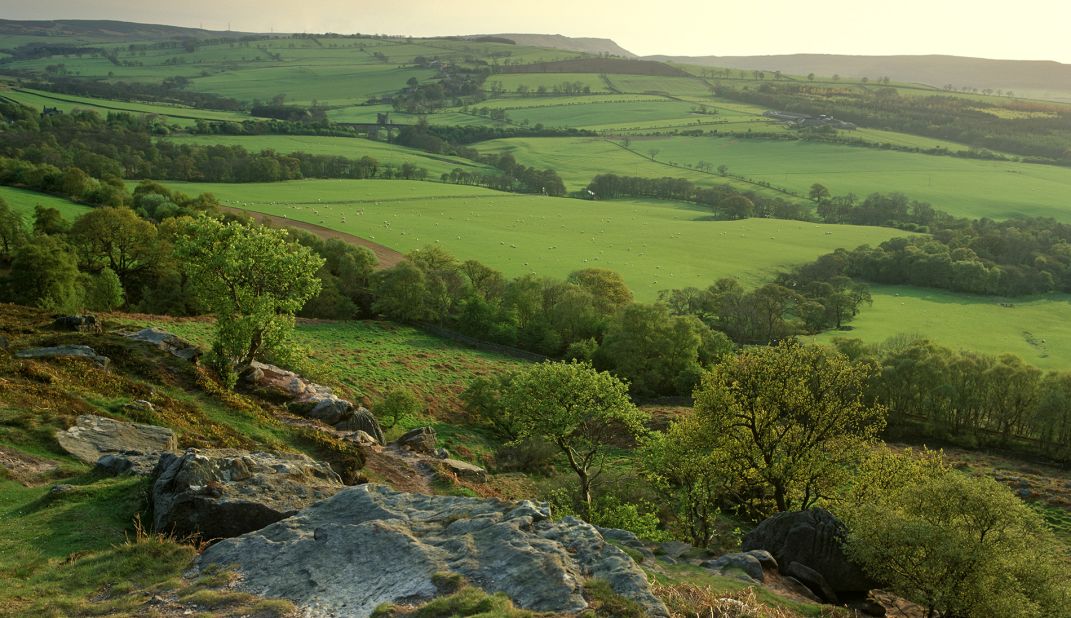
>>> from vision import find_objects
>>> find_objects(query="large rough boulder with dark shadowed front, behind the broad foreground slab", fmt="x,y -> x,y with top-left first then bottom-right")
150,449 -> 343,539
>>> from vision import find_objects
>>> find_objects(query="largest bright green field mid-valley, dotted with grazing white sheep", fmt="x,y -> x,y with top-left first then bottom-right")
160,180 -> 904,302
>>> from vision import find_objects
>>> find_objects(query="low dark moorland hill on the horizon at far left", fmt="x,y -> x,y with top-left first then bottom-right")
0,19 -> 247,41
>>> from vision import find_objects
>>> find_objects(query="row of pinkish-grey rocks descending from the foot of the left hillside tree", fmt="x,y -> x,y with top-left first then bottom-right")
242,361 -> 384,444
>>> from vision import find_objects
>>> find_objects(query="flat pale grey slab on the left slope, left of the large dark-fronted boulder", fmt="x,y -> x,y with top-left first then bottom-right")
56,414 -> 179,464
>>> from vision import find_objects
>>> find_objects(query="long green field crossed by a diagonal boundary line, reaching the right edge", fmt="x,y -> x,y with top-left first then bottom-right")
481,136 -> 1071,222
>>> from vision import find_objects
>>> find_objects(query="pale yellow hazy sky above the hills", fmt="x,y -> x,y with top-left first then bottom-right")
6,0 -> 1071,63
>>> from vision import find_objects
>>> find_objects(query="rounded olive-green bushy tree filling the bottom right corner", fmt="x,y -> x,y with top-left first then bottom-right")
836,449 -> 1071,617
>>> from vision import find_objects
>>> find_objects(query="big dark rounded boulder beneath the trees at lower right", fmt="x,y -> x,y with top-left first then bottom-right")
742,508 -> 877,597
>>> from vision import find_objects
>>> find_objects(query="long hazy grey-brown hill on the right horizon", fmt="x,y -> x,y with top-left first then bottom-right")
648,54 -> 1071,96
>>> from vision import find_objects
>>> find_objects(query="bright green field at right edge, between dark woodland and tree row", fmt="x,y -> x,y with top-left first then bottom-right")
815,285 -> 1071,370
